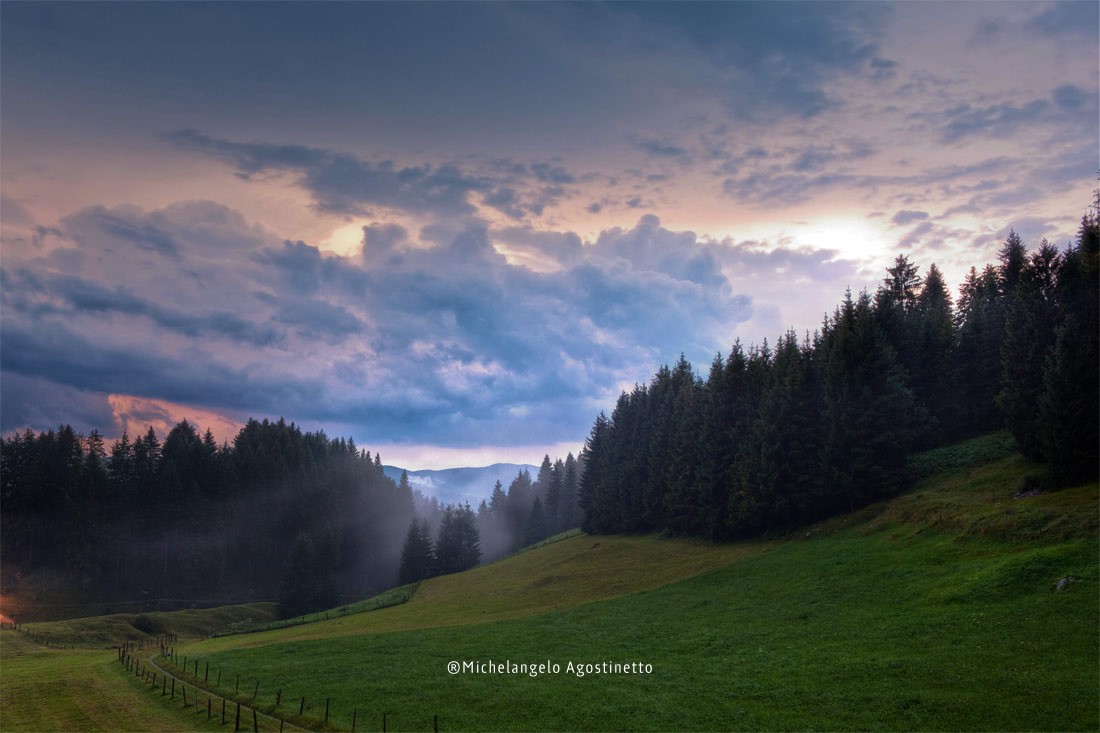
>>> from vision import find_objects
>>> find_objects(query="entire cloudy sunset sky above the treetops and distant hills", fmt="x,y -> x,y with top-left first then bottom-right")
0,0 -> 1100,469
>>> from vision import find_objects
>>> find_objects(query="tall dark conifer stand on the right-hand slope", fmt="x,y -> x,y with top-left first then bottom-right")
580,200 -> 1100,539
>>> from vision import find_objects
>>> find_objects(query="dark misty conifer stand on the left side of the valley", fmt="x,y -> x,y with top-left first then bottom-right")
0,419 -> 414,612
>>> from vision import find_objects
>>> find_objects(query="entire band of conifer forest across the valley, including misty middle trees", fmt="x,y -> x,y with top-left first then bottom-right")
0,198 -> 1100,617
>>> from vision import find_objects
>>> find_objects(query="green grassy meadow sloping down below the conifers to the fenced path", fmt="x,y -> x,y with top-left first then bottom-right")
0,436 -> 1100,731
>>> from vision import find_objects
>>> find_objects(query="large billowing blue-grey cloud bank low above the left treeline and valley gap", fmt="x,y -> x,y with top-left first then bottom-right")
0,201 -> 836,446
